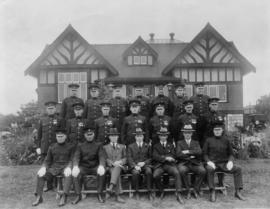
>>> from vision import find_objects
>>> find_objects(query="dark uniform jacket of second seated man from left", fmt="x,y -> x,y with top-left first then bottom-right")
73,141 -> 106,168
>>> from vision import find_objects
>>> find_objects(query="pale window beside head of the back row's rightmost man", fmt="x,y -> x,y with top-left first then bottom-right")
205,85 -> 227,102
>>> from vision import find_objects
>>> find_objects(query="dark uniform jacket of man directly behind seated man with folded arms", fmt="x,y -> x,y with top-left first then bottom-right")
175,113 -> 199,140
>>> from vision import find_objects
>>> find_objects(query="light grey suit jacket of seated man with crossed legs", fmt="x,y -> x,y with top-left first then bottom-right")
103,143 -> 127,167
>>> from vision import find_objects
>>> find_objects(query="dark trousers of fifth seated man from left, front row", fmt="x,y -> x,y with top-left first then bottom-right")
153,164 -> 181,192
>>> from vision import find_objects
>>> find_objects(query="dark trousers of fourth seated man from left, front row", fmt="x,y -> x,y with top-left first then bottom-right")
131,166 -> 152,192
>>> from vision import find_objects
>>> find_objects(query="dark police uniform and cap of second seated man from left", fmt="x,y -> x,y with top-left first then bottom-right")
73,126 -> 106,203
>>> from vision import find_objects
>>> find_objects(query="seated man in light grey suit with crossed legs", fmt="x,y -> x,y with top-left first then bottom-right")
104,128 -> 127,203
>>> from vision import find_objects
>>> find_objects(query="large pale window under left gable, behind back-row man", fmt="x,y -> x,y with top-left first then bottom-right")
58,72 -> 87,102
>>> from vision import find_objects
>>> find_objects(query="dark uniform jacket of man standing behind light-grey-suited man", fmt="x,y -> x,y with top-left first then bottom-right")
95,116 -> 119,144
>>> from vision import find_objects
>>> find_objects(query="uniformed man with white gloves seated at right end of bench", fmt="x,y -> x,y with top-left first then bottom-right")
203,121 -> 245,202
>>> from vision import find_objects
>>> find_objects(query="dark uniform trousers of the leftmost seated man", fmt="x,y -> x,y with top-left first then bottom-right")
35,171 -> 72,196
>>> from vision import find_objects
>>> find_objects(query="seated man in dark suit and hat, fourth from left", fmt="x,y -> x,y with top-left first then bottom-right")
127,128 -> 153,200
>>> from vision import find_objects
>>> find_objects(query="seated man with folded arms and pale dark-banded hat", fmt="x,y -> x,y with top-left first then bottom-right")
176,124 -> 206,199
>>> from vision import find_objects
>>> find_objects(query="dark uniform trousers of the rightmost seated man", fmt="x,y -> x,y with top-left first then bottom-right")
206,163 -> 243,189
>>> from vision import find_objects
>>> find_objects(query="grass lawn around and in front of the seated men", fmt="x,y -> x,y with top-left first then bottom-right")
0,159 -> 270,209
